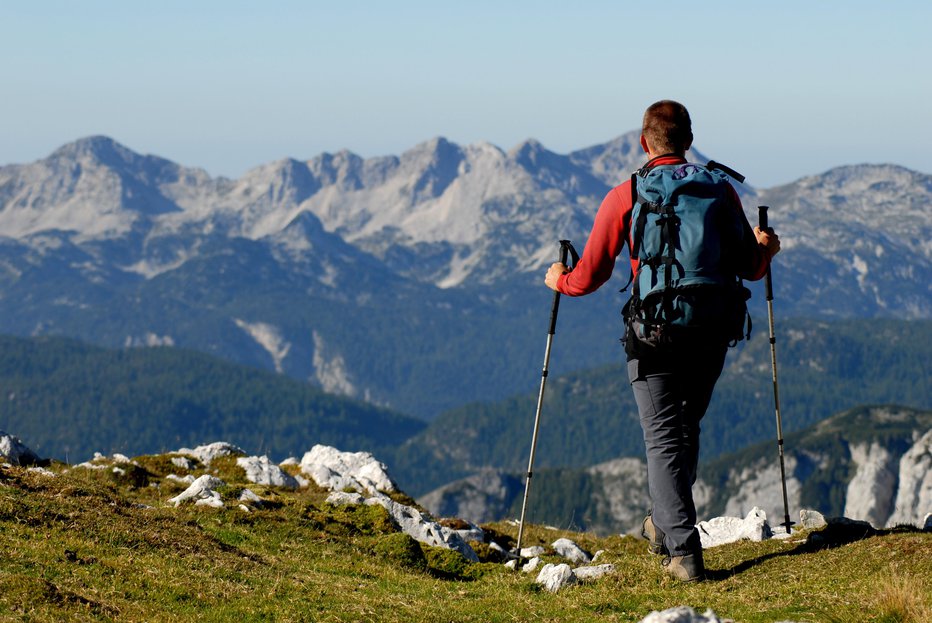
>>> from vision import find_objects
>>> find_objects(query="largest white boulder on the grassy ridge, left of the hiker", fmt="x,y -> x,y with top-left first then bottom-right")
301,444 -> 396,494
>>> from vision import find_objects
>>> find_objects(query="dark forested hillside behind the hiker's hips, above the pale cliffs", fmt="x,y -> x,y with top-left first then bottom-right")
389,319 -> 932,495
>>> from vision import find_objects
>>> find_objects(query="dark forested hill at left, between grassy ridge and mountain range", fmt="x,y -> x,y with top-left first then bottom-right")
0,336 -> 425,462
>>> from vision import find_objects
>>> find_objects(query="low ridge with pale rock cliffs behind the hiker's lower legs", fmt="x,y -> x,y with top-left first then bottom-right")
419,406 -> 932,534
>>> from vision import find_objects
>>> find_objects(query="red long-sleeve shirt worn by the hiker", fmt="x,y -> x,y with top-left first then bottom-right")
557,156 -> 770,296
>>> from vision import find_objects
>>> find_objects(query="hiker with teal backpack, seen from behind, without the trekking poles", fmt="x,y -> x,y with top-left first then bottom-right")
544,100 -> 780,581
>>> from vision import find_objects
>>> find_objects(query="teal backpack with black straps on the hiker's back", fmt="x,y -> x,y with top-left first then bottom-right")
622,162 -> 751,356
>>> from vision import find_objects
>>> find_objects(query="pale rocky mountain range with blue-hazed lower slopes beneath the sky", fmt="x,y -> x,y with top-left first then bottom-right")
0,132 -> 932,418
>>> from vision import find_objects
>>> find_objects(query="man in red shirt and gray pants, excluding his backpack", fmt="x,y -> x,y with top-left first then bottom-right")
544,100 -> 780,581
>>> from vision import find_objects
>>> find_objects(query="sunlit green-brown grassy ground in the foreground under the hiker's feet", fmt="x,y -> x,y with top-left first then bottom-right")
0,456 -> 932,623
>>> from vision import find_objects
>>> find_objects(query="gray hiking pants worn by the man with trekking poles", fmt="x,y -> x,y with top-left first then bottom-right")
628,345 -> 728,556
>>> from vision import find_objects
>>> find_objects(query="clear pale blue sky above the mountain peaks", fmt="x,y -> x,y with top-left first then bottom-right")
0,0 -> 932,187
